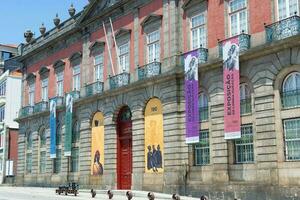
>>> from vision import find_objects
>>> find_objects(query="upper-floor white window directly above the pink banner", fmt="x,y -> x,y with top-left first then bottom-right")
229,0 -> 248,36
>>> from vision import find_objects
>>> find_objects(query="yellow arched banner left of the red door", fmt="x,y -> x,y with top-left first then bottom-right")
91,112 -> 104,176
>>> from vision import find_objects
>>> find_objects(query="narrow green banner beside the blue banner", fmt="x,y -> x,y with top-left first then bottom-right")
64,94 -> 73,156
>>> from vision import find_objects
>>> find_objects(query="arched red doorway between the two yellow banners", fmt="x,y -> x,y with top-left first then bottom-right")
117,106 -> 132,189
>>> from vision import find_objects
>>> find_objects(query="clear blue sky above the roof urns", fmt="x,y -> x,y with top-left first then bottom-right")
0,0 -> 88,44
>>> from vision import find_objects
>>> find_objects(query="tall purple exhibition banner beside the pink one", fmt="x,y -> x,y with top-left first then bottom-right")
184,50 -> 199,144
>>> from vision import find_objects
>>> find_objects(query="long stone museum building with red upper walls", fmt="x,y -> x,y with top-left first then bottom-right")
16,0 -> 300,200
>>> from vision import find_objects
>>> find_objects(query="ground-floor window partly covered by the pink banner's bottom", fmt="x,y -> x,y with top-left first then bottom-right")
235,124 -> 254,163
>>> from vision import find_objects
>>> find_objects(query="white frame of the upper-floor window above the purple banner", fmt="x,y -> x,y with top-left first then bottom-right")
190,13 -> 207,50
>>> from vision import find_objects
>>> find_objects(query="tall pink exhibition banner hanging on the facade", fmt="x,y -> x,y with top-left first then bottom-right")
222,37 -> 241,140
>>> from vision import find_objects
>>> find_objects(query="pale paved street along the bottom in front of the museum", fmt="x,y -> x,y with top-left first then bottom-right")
0,186 -> 195,200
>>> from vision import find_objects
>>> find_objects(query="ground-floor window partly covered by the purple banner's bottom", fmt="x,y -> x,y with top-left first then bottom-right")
194,130 -> 210,165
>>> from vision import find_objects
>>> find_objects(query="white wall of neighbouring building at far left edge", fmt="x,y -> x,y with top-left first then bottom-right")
4,76 -> 22,128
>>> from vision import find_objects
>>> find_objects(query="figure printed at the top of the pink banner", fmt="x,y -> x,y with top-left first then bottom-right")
223,44 -> 238,71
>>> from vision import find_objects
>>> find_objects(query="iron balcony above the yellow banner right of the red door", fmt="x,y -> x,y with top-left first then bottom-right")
138,61 -> 161,80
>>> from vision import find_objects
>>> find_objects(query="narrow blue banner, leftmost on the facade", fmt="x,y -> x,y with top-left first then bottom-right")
50,99 -> 56,158
